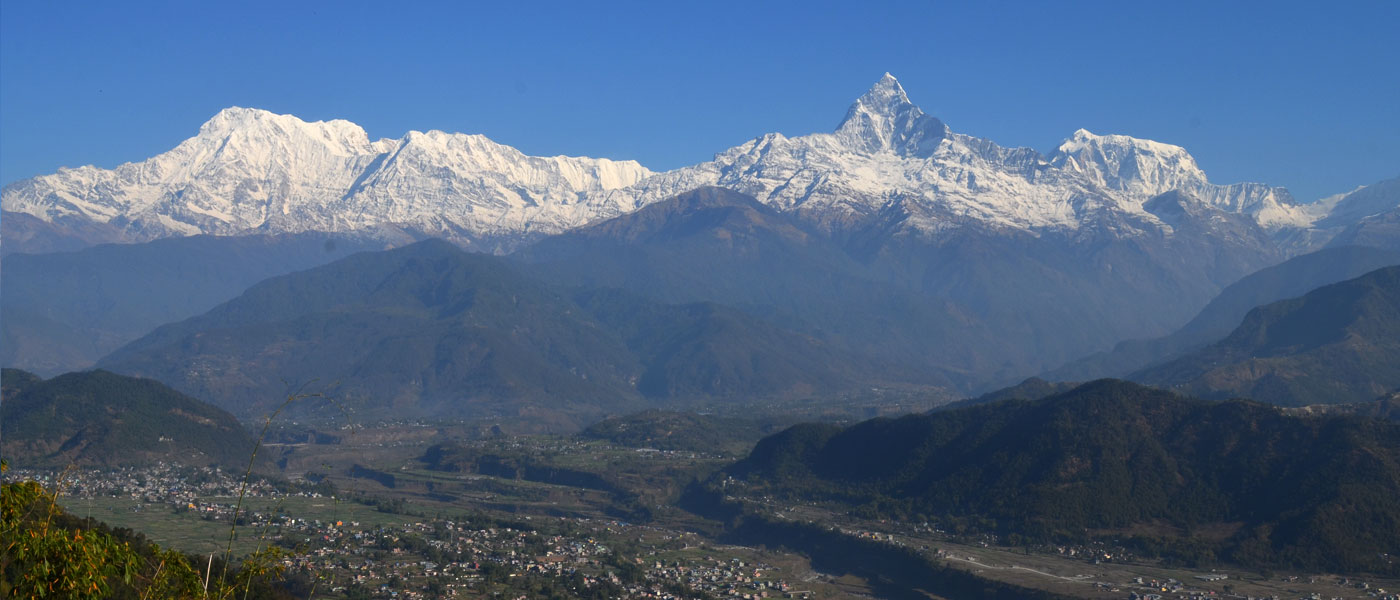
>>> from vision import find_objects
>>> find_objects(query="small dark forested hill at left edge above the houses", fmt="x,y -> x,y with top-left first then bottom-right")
0,369 -> 253,469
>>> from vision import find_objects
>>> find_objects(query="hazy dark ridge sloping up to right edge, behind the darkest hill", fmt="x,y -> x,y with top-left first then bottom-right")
1131,266 -> 1400,406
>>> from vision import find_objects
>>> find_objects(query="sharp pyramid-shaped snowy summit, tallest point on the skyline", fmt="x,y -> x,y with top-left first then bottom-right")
836,73 -> 948,158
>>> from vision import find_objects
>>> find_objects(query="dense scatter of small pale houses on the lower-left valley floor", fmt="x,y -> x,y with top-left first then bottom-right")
6,464 -> 811,600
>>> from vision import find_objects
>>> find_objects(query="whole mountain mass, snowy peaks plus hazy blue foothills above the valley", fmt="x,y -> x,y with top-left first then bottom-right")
0,74 -> 1400,414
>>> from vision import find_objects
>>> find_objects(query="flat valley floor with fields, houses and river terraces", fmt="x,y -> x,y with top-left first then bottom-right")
7,427 -> 1400,600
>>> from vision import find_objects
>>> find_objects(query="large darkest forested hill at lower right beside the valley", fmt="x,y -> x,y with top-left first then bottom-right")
729,380 -> 1400,572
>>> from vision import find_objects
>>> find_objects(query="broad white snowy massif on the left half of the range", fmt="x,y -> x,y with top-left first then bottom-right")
3,106 -> 651,245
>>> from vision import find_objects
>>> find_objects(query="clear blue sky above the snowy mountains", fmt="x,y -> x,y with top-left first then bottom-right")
0,0 -> 1400,200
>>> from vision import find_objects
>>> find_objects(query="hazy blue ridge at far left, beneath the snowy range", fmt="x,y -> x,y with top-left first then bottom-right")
0,234 -> 385,376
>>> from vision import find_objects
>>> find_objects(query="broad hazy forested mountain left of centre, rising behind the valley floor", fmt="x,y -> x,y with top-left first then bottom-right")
98,239 -> 940,427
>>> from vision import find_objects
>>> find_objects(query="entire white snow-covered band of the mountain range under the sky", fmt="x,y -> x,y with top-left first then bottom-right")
0,74 -> 1372,249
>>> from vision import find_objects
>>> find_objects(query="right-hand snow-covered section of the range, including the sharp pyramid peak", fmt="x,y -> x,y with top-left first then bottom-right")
608,74 -> 1316,235
